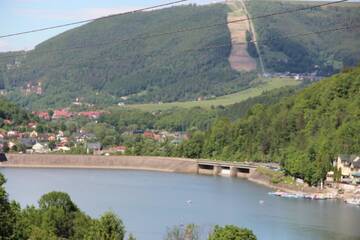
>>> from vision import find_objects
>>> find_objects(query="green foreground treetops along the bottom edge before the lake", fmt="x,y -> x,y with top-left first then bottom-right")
0,173 -> 256,240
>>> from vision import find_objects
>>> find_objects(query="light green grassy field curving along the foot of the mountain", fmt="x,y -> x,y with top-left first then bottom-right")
125,78 -> 300,111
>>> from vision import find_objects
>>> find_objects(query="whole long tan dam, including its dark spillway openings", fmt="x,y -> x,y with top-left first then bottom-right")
0,154 -> 258,178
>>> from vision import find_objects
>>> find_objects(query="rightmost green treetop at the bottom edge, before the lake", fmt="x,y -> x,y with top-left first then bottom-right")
209,225 -> 257,240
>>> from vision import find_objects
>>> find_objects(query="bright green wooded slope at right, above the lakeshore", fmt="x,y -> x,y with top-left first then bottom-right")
178,67 -> 360,184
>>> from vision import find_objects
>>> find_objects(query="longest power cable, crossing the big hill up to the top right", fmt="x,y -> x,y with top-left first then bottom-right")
0,0 -> 348,59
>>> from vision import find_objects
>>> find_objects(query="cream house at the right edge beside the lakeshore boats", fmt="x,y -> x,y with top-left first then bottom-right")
335,154 -> 360,184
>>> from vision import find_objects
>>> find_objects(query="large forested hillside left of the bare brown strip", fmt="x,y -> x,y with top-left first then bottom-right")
0,4 -> 255,107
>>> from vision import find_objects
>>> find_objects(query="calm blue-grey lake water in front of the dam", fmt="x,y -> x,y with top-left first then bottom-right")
0,169 -> 360,240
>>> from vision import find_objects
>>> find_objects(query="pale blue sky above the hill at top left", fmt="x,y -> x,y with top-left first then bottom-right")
0,0 -> 219,52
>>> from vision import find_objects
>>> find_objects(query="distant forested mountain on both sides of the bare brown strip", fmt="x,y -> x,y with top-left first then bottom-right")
0,0 -> 360,109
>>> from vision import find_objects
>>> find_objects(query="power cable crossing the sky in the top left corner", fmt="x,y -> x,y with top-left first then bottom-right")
0,0 -> 189,38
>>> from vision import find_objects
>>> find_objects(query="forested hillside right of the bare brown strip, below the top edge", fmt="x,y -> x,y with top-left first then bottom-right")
246,0 -> 360,75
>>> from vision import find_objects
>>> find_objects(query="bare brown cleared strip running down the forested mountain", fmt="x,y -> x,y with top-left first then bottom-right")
226,0 -> 256,72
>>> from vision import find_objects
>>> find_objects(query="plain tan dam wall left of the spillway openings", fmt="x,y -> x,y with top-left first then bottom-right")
0,154 -> 198,174
